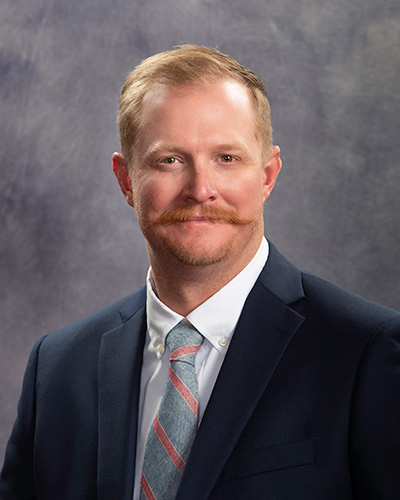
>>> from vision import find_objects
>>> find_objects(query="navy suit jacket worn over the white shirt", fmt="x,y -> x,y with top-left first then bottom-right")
0,241 -> 400,500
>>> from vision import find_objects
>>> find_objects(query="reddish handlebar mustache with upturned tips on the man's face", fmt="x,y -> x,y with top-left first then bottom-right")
147,206 -> 251,228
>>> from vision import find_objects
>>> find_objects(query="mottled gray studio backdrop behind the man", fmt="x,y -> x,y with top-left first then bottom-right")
0,0 -> 400,456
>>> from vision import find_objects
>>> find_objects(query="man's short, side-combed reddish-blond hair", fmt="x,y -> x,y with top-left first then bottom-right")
117,44 -> 272,165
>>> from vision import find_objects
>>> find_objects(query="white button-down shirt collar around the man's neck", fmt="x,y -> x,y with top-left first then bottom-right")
146,238 -> 269,357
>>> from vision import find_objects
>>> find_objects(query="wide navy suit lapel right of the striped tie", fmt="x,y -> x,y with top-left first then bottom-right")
176,241 -> 304,500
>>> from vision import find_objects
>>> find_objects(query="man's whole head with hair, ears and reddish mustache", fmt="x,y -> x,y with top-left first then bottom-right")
113,46 -> 281,277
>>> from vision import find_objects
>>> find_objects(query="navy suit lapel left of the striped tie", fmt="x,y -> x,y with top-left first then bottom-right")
98,300 -> 146,500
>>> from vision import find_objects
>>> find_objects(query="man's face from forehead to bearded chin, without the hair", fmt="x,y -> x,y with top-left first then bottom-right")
114,80 -> 280,272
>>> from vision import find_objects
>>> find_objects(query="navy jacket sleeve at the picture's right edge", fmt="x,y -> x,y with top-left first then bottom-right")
349,316 -> 400,500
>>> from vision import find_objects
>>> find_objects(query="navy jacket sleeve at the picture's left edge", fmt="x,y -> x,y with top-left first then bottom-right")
0,337 -> 45,500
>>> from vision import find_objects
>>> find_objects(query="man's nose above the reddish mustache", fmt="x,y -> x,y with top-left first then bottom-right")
182,162 -> 217,203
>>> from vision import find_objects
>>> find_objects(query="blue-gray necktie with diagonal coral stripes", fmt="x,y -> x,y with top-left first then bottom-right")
140,323 -> 203,500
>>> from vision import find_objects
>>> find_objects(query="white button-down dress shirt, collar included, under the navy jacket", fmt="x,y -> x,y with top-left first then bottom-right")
133,238 -> 269,500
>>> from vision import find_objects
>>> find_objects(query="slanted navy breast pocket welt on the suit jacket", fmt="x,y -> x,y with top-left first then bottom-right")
221,439 -> 315,480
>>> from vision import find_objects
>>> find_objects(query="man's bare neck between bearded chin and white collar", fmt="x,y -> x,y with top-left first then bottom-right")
149,236 -> 260,316
